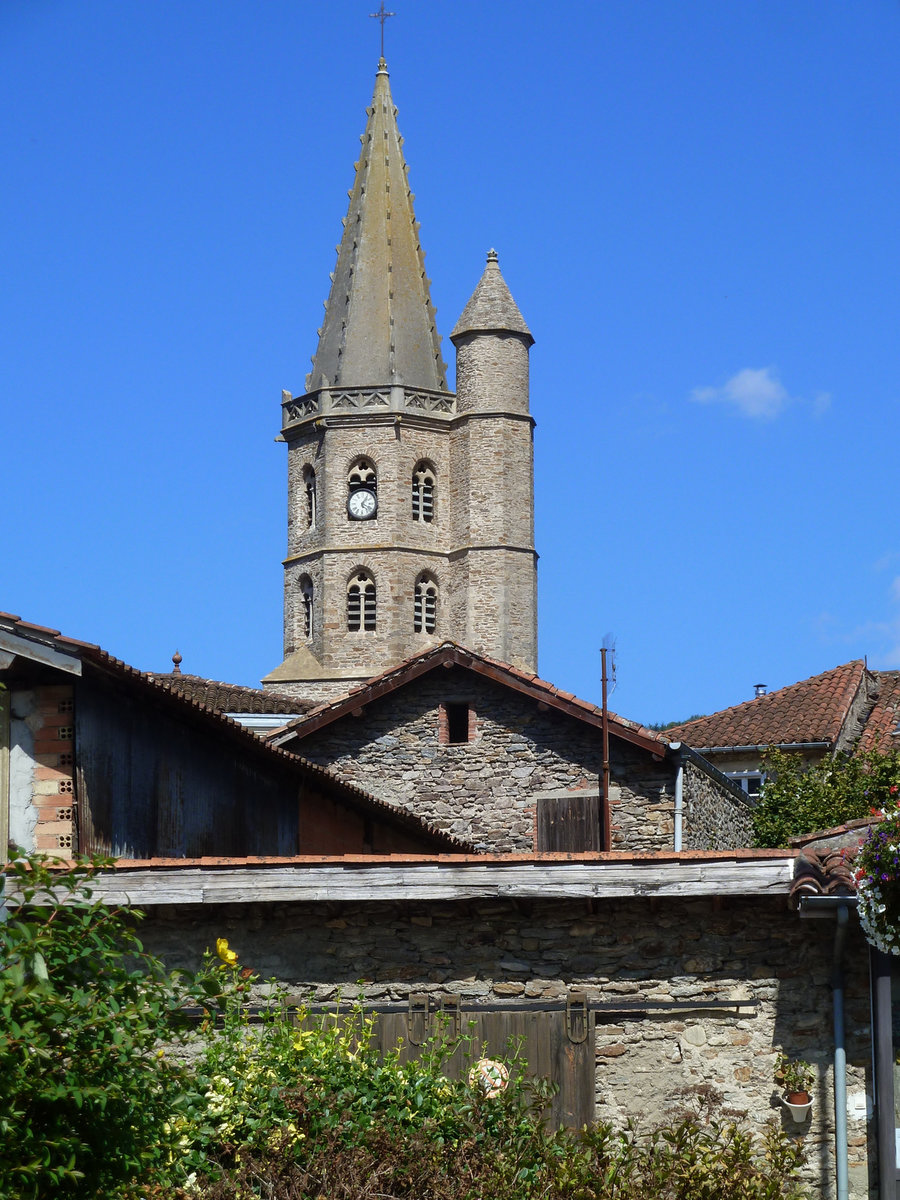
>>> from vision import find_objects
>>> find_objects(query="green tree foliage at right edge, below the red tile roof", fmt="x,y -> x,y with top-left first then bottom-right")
754,749 -> 900,847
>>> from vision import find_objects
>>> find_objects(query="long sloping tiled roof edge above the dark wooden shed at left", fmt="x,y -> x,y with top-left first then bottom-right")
0,612 -> 473,852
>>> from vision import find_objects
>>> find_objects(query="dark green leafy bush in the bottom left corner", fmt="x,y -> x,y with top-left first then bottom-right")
0,852 -> 224,1200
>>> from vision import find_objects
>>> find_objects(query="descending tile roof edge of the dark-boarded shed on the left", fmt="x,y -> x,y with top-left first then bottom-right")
0,612 -> 474,853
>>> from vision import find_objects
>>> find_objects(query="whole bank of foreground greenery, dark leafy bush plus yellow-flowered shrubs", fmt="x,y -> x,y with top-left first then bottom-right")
0,854 -> 805,1200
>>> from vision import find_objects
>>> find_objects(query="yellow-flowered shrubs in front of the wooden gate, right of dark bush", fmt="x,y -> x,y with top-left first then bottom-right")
180,955 -> 806,1200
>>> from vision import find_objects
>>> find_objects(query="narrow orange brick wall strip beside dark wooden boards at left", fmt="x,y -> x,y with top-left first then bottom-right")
32,684 -> 77,856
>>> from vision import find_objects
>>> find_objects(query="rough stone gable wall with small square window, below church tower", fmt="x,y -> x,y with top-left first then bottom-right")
295,667 -> 674,853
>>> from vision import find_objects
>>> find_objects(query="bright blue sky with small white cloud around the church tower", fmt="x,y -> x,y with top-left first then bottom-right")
0,0 -> 900,721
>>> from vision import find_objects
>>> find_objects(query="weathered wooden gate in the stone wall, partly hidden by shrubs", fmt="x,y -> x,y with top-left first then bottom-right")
312,992 -> 595,1129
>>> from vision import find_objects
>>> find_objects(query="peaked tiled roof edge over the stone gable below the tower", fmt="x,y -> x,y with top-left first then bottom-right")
269,641 -> 674,756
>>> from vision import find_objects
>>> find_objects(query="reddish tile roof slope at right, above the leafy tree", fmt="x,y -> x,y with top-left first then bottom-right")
666,659 -> 866,751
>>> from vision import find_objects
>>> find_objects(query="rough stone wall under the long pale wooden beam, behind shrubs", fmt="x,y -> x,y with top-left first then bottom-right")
142,898 -> 871,1200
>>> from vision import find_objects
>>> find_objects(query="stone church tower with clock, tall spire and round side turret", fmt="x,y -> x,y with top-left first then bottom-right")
263,59 -> 538,702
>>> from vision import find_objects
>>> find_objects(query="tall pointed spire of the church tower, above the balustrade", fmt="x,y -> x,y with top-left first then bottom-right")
306,59 -> 446,391
